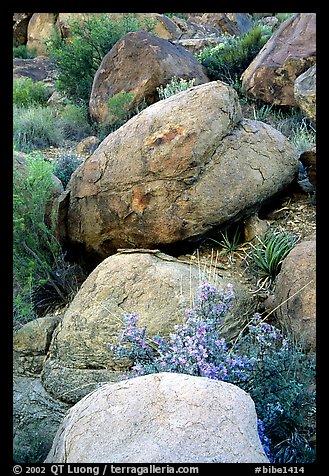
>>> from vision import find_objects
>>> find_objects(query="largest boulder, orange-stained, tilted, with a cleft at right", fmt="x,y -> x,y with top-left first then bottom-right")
58,81 -> 298,258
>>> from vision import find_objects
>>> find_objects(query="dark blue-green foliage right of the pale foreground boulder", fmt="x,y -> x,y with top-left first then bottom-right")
235,314 -> 316,463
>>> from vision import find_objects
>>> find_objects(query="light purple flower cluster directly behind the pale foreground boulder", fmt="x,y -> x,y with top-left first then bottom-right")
111,282 -> 253,383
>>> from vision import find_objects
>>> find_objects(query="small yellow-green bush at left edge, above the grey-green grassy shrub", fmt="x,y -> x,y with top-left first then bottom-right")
13,78 -> 50,107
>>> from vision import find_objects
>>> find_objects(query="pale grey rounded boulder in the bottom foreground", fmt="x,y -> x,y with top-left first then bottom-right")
45,372 -> 268,464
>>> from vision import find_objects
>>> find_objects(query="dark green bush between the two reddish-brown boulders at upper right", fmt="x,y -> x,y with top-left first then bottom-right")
196,26 -> 270,85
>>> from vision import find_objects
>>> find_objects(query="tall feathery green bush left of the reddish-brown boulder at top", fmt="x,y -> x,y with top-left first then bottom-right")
47,13 -> 153,105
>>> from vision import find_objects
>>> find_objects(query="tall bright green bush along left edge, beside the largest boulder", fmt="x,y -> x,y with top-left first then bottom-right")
13,153 -> 82,322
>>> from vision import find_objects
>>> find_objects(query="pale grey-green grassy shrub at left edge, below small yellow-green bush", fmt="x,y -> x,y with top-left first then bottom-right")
13,106 -> 64,152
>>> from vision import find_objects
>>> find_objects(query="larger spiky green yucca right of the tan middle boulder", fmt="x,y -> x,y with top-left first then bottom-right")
246,228 -> 299,287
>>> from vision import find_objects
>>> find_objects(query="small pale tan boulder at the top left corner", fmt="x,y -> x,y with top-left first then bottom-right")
27,13 -> 59,55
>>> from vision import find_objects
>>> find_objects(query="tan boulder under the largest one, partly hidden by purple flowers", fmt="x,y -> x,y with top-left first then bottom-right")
42,250 -> 257,403
